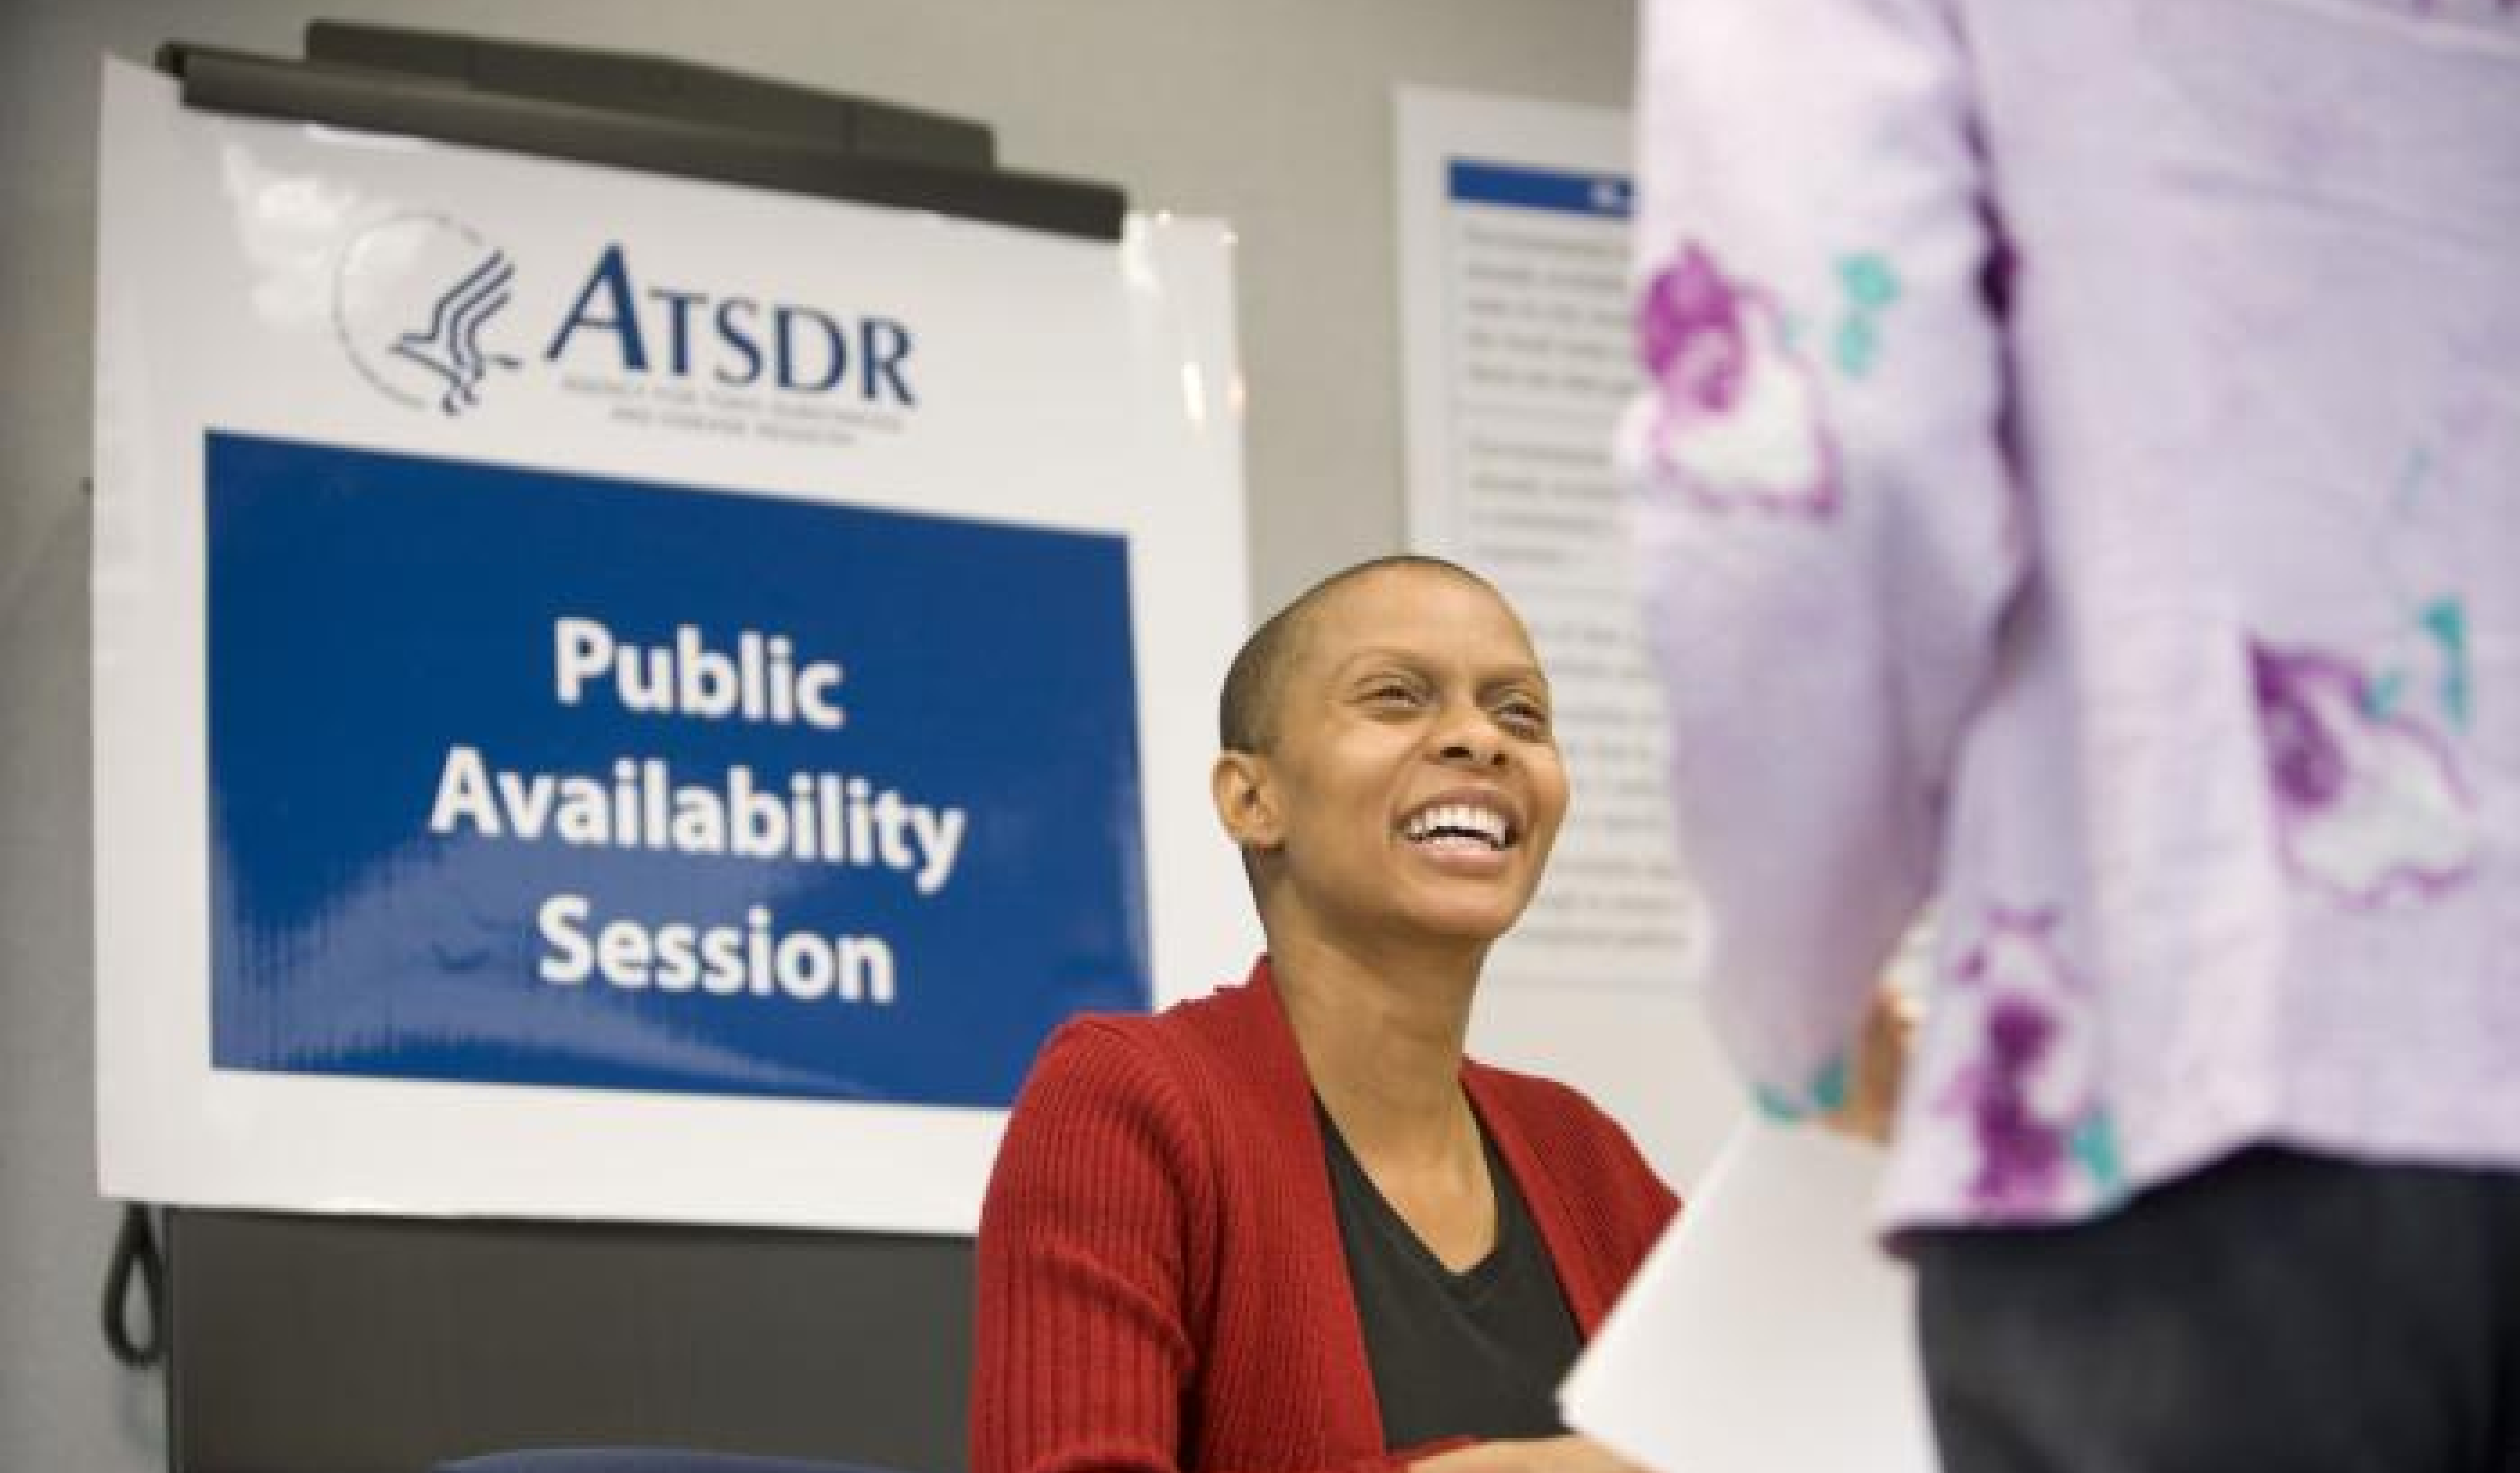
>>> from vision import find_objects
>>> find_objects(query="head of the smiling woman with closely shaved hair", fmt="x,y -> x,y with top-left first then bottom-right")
1214,560 -> 1567,958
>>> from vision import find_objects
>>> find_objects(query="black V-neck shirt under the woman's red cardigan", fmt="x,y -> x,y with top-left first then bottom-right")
1313,1100 -> 1583,1453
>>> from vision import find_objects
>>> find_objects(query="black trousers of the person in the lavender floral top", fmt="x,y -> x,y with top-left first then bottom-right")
1910,1150 -> 2520,1473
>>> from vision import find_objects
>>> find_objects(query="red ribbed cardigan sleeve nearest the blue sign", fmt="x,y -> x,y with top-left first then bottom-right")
970,1019 -> 1396,1473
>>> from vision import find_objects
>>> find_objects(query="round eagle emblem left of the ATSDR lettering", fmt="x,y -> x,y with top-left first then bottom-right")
333,214 -> 516,414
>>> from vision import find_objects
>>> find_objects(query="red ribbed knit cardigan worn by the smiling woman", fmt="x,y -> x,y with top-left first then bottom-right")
970,958 -> 1679,1473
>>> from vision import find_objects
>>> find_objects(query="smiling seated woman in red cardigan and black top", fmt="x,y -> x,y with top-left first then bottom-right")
973,557 -> 1679,1473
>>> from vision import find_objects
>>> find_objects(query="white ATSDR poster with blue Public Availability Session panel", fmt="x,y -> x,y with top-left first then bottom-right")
95,63 -> 1258,1231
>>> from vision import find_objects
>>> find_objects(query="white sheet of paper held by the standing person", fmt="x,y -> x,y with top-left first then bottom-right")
1560,1120 -> 1936,1473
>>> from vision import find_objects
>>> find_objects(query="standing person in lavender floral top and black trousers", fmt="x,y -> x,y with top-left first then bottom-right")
1620,0 -> 2520,1473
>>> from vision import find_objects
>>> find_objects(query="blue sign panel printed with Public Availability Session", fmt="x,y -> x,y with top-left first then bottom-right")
207,434 -> 1149,1107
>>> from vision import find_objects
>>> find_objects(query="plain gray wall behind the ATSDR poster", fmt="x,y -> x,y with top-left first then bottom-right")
0,0 -> 1633,1473
